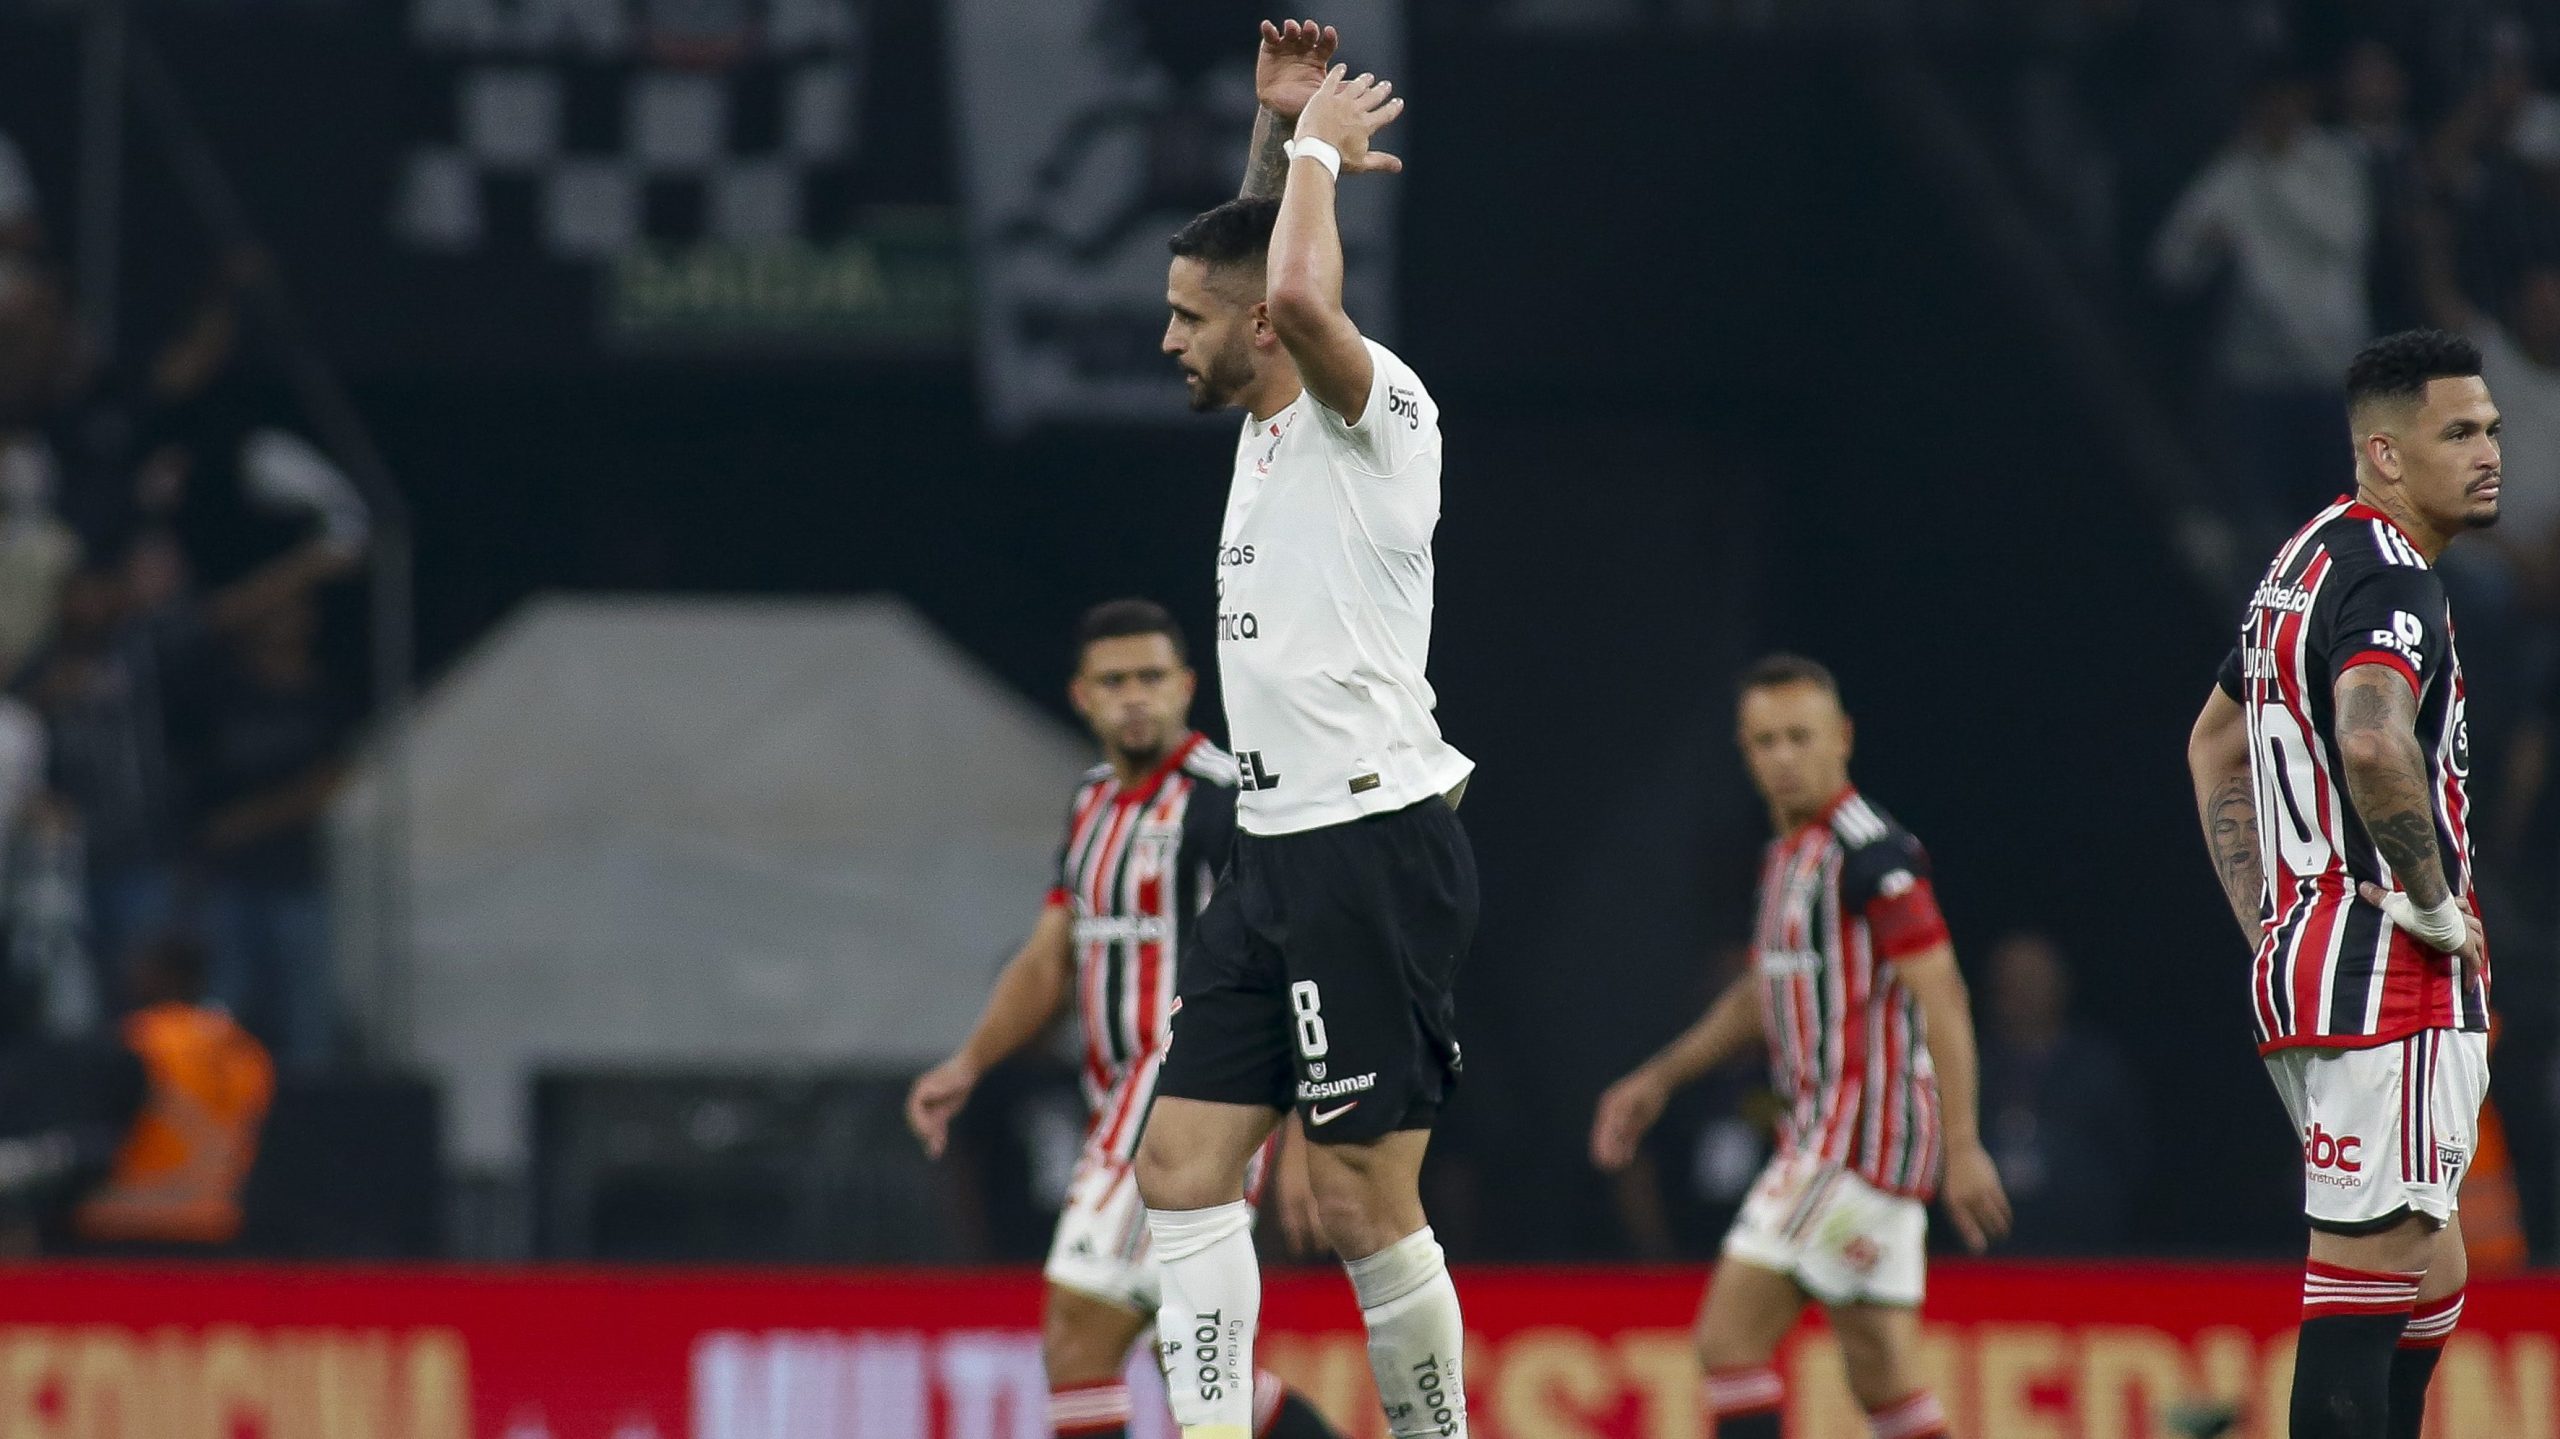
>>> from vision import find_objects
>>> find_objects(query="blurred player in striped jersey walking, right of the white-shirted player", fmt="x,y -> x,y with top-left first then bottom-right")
1592,655 -> 2010,1439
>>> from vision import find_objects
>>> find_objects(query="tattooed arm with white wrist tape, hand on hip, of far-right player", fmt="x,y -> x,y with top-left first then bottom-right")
2335,663 -> 2481,970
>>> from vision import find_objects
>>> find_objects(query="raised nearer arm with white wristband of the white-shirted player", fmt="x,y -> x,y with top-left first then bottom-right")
1267,64 -> 1405,425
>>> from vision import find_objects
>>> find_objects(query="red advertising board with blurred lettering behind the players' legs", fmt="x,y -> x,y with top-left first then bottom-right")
0,1265 -> 2560,1439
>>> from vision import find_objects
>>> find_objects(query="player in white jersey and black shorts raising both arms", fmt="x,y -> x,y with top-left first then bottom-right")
1137,23 -> 1477,1439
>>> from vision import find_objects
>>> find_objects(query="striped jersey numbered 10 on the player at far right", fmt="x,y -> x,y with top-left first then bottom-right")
2220,499 -> 2488,1052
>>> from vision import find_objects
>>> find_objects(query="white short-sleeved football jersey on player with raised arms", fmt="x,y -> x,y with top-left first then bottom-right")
1219,341 -> 1475,835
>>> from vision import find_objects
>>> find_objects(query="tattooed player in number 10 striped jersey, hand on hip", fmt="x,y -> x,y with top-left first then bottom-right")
2186,330 -> 2499,1439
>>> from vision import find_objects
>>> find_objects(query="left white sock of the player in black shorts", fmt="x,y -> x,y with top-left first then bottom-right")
1147,1198 -> 1262,1439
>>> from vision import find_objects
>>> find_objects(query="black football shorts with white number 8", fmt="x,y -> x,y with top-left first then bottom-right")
1157,796 -> 1477,1145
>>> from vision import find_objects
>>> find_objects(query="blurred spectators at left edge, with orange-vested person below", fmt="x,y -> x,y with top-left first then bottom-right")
0,138 -> 369,1242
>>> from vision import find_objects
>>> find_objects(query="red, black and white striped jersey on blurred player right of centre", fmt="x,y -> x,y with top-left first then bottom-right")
1751,789 -> 1946,1198
